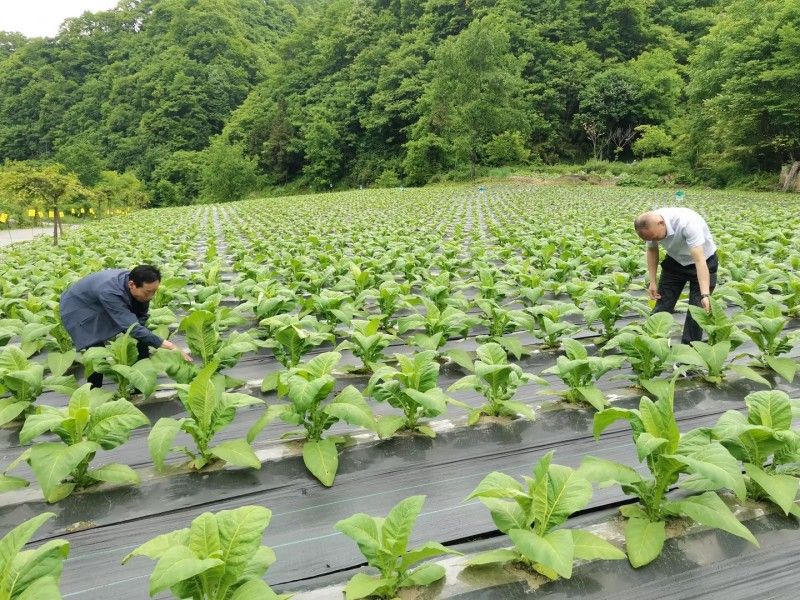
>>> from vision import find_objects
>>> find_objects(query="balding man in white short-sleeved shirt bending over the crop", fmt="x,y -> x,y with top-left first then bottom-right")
634,208 -> 719,344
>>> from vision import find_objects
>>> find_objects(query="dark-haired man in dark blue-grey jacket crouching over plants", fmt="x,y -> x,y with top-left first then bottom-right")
61,265 -> 192,387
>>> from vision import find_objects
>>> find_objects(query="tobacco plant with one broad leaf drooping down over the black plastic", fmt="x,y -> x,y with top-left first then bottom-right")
247,352 -> 376,487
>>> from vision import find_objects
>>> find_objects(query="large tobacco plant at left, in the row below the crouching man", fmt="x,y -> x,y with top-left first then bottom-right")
7,383 -> 150,503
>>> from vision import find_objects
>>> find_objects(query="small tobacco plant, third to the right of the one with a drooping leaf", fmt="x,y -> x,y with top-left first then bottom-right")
542,338 -> 625,410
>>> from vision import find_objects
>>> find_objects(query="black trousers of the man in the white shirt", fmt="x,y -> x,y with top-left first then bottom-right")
653,253 -> 719,344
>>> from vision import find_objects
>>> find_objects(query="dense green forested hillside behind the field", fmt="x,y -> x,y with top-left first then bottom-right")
0,0 -> 800,205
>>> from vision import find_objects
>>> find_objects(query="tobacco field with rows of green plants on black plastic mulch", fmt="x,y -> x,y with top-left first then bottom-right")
0,183 -> 800,600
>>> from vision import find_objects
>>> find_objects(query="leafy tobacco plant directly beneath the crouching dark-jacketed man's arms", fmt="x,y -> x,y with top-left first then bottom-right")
80,330 -> 158,400
